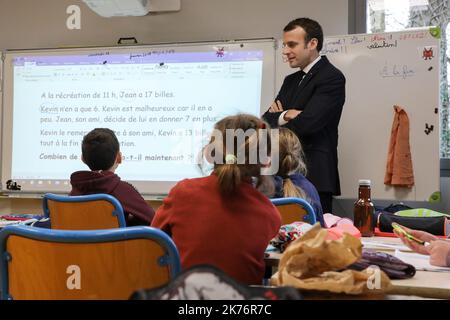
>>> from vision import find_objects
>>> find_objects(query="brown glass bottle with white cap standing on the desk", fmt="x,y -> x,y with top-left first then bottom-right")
353,180 -> 374,237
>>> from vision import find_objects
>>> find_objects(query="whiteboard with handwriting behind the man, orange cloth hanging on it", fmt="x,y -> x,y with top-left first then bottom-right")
277,28 -> 440,201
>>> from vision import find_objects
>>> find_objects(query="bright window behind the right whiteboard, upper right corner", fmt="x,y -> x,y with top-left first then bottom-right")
366,0 -> 450,158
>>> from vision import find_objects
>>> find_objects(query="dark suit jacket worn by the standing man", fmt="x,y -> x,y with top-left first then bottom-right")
263,56 -> 345,195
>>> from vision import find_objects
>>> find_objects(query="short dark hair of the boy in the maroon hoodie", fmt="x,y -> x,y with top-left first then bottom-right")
81,128 -> 120,171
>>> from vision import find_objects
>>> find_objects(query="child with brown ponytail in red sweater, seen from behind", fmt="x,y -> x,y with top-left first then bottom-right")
152,114 -> 281,284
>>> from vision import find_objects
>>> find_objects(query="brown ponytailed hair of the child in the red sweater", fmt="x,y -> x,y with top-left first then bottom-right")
204,114 -> 274,195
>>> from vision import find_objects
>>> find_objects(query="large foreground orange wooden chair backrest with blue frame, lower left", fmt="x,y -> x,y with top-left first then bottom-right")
0,225 -> 180,300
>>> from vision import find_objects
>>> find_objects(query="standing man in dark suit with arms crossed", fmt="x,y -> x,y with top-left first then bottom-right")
263,18 -> 345,212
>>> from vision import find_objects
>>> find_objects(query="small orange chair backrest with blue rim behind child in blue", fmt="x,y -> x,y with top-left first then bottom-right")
271,197 -> 317,224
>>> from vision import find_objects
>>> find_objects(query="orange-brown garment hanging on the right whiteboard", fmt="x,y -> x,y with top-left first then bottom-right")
384,106 -> 414,188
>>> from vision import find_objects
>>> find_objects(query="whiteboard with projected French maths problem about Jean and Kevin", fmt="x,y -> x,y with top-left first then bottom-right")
1,39 -> 275,195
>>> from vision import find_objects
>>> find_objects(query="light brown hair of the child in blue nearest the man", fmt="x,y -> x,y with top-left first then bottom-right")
278,128 -> 308,200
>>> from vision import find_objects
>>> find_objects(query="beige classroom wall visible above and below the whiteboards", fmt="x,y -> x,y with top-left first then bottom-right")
0,0 -> 450,216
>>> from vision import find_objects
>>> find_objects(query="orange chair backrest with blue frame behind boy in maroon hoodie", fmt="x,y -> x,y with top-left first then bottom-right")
43,193 -> 126,230
